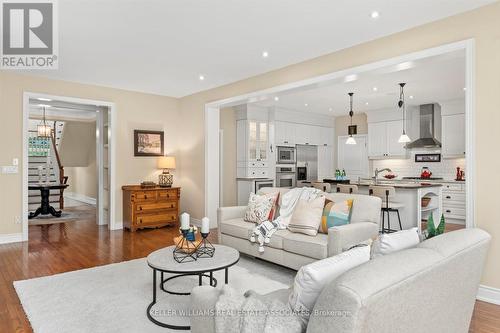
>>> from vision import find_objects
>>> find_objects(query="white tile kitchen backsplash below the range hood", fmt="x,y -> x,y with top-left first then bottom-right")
370,151 -> 467,180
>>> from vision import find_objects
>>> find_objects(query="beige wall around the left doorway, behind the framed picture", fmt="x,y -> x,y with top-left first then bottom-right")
0,71 -> 180,234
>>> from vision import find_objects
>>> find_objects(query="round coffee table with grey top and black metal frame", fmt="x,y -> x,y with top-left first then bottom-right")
146,244 -> 240,330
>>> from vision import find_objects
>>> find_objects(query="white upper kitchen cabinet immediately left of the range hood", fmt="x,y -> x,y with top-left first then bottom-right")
368,120 -> 407,159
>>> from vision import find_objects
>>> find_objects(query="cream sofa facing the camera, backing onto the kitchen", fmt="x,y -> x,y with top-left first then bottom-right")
218,188 -> 382,269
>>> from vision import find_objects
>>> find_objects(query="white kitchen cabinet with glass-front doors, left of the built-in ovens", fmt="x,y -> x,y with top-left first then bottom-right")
236,120 -> 269,178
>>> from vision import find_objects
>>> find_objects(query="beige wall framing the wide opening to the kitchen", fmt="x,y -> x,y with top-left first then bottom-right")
180,3 -> 500,288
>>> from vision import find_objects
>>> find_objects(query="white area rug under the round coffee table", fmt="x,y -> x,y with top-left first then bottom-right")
14,256 -> 295,333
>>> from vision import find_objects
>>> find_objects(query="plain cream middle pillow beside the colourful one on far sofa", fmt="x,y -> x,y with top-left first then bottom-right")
288,196 -> 325,236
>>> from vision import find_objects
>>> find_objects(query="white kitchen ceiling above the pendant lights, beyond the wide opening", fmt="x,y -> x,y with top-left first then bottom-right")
255,50 -> 465,116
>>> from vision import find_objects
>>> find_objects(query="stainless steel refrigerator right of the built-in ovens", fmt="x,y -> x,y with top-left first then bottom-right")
296,145 -> 318,187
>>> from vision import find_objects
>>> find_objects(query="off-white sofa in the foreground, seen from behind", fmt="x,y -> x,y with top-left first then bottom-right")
191,229 -> 491,333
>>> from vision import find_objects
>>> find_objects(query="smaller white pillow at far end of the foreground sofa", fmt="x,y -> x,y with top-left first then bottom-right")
372,228 -> 420,258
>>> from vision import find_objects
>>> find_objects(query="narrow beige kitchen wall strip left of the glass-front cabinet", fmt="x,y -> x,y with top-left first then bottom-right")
220,108 -> 238,206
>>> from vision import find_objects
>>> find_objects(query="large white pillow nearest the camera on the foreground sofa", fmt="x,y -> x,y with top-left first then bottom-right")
288,245 -> 370,324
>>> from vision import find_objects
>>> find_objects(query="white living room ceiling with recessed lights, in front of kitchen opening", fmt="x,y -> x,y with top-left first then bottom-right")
21,0 -> 496,97
